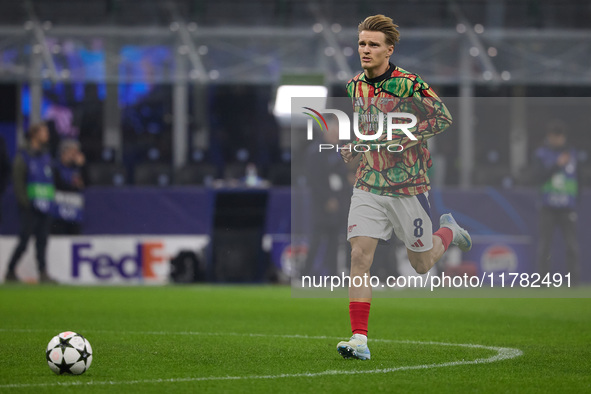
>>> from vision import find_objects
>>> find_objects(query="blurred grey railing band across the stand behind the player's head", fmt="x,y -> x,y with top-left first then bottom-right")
0,22 -> 591,85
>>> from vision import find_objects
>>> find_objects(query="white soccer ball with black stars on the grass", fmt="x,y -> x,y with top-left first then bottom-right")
45,331 -> 92,375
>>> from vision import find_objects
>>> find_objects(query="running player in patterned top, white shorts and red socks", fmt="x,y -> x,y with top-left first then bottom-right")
337,15 -> 472,360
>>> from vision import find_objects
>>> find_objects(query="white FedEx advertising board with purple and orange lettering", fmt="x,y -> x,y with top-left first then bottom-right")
0,235 -> 209,284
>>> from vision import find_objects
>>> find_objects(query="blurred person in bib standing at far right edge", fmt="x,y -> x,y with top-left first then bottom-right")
536,123 -> 580,284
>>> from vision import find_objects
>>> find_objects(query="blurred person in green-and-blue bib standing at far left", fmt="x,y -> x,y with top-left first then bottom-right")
6,123 -> 55,283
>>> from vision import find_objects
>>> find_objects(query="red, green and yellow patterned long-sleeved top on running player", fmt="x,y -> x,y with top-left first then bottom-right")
347,64 -> 452,196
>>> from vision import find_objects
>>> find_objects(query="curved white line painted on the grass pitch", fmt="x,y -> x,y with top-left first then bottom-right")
0,328 -> 523,389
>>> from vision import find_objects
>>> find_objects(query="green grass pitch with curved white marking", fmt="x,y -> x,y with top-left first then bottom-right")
0,285 -> 591,393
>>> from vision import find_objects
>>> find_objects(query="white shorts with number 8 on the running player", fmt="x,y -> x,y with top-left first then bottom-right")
347,189 -> 433,252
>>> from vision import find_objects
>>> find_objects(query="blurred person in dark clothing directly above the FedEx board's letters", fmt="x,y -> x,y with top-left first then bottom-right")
51,139 -> 86,235
